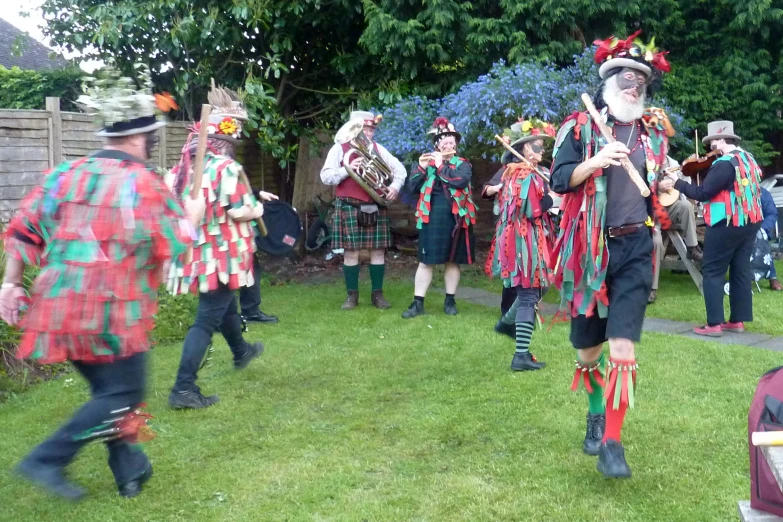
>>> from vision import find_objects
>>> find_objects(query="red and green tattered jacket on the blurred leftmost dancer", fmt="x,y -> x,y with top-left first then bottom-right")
4,151 -> 190,364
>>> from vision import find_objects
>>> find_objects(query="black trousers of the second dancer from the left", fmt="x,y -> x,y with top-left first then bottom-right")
172,285 -> 247,392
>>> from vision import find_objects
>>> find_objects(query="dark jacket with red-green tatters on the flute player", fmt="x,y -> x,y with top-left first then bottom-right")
409,156 -> 478,229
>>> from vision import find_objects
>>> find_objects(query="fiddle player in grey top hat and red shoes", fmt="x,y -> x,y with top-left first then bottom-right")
670,121 -> 763,337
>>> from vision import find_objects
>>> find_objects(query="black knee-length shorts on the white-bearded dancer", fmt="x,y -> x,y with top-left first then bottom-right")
571,227 -> 653,350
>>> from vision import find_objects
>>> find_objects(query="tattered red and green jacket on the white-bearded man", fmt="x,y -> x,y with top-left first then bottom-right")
552,112 -> 667,318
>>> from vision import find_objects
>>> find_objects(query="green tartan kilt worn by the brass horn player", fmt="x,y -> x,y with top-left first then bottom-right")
332,198 -> 392,250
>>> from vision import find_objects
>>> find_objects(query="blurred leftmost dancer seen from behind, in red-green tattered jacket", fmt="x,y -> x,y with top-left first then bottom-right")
0,71 -> 196,499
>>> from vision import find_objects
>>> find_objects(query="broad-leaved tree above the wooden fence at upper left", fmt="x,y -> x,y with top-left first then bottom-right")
37,0 -> 404,162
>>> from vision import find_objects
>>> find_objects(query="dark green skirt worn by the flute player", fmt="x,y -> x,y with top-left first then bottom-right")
418,191 -> 476,265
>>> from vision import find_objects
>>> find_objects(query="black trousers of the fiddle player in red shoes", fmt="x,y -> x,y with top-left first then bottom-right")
701,222 -> 761,326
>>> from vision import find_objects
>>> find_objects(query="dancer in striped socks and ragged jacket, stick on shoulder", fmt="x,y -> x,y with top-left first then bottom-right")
487,118 -> 555,371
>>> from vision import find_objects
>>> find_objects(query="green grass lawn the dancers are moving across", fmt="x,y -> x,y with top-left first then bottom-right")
0,283 -> 781,522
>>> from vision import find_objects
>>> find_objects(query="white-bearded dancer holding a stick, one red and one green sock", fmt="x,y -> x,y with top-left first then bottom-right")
552,33 -> 669,477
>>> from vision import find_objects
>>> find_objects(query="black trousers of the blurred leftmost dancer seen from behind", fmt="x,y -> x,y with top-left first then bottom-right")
25,353 -> 149,486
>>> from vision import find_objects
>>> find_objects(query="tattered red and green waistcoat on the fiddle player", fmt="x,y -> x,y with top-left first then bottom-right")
704,150 -> 763,227
